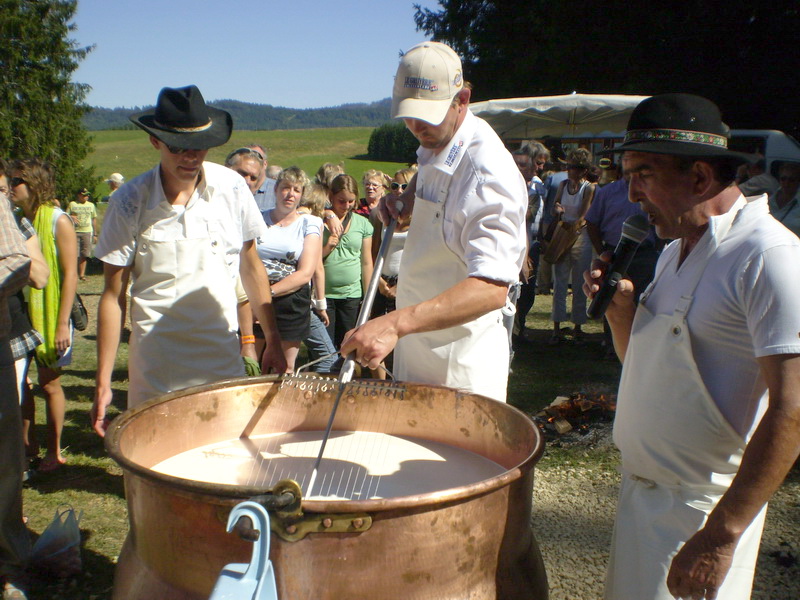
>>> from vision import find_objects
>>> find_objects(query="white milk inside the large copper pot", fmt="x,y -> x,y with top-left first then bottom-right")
152,431 -> 506,500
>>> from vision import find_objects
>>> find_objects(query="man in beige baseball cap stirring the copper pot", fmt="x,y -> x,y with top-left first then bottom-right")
342,42 -> 528,401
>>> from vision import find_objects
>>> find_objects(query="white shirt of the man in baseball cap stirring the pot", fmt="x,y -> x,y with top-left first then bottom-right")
411,111 -> 528,284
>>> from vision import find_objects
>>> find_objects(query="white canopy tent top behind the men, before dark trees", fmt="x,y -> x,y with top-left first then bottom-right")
469,93 -> 648,139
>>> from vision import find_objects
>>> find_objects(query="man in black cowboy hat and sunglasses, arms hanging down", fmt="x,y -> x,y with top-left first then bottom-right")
92,86 -> 286,435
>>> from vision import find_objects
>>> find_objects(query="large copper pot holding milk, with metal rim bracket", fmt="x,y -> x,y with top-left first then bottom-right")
106,377 -> 547,600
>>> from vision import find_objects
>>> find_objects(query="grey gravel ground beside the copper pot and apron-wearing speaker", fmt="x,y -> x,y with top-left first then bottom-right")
533,432 -> 800,600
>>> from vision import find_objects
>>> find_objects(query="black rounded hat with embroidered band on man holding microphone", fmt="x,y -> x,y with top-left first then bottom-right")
598,94 -> 756,163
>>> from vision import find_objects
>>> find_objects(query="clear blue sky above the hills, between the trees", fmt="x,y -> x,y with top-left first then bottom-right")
72,0 -> 438,108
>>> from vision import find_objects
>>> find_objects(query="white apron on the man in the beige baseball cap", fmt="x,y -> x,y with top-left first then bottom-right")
394,173 -> 509,402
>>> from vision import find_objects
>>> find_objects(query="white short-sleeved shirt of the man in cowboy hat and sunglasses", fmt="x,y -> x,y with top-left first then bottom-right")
95,162 -> 266,276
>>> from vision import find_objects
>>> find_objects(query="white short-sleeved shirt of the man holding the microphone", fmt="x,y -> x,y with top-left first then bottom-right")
646,196 -> 800,437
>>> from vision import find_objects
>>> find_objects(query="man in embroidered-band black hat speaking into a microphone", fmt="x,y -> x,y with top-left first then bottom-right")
584,94 -> 800,600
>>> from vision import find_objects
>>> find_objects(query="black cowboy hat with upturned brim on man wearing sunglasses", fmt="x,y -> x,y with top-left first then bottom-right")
129,85 -> 233,150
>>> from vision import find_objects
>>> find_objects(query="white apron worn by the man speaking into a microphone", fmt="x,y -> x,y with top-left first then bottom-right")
605,204 -> 766,600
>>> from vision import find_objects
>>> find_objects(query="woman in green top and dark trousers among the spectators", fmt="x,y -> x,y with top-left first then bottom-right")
322,175 -> 373,348
